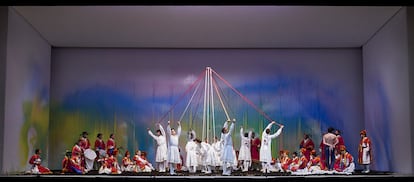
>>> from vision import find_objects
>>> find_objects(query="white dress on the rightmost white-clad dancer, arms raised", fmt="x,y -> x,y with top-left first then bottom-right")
260,123 -> 283,164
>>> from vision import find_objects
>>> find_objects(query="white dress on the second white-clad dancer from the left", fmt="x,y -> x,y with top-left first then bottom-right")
167,124 -> 181,164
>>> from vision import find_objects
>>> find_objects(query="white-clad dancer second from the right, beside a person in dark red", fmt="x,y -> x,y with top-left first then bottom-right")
238,127 -> 252,172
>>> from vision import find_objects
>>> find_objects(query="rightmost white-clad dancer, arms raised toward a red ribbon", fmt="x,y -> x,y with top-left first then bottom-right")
260,121 -> 284,173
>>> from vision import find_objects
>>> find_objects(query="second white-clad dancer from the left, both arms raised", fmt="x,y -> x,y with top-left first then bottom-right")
167,121 -> 181,175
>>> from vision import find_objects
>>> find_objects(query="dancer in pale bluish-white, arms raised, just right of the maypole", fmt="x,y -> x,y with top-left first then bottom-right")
221,119 -> 236,176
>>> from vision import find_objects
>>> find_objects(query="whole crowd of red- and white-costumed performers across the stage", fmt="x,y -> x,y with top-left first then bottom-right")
29,119 -> 372,176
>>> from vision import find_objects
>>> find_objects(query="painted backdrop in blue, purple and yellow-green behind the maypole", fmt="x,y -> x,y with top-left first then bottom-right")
49,48 -> 370,168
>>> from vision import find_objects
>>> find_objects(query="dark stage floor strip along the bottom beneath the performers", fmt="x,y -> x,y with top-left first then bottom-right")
0,171 -> 414,182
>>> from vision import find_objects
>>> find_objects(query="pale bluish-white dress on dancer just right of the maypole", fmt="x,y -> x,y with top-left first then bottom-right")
220,122 -> 236,164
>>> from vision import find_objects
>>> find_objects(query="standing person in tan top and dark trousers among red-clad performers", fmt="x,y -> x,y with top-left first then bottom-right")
322,127 -> 338,171
